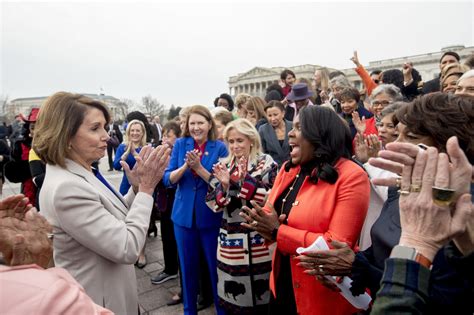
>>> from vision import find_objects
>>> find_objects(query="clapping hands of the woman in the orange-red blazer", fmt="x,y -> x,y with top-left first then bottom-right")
239,204 -> 286,241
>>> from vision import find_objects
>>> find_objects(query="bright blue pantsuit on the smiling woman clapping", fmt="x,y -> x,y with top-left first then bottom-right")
163,137 -> 227,314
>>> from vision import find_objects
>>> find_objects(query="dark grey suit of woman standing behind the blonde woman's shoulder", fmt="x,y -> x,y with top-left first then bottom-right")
258,120 -> 292,166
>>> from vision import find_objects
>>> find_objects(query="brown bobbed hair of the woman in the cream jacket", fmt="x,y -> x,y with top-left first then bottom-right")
32,92 -> 110,168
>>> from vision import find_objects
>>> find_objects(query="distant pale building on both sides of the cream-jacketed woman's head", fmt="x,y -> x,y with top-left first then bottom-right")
7,94 -> 128,121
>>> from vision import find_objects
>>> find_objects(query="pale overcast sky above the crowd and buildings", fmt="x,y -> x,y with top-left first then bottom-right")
0,1 -> 474,106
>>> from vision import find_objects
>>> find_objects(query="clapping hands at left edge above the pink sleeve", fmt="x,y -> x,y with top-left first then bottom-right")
0,194 -> 53,268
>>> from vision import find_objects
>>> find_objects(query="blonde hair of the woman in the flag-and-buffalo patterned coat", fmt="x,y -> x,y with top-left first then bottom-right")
222,118 -> 262,164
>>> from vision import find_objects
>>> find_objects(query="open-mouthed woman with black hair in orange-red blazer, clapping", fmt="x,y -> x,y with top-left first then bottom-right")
241,106 -> 369,314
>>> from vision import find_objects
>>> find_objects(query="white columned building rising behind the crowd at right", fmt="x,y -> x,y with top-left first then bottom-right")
228,45 -> 474,98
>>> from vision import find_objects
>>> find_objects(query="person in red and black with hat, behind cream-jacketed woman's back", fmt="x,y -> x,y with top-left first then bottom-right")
5,108 -> 39,206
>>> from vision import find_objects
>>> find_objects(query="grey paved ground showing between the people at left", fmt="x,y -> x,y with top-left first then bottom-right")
3,159 -> 215,315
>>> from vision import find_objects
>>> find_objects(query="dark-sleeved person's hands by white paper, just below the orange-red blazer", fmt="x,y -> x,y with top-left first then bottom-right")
295,240 -> 355,276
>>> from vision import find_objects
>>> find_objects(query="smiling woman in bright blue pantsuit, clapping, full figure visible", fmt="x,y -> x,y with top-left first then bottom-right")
163,105 -> 227,314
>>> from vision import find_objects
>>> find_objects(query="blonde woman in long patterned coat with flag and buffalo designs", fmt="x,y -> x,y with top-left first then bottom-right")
206,119 -> 278,314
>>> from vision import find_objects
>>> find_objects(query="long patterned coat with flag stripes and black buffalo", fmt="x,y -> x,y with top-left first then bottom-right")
206,154 -> 278,314
